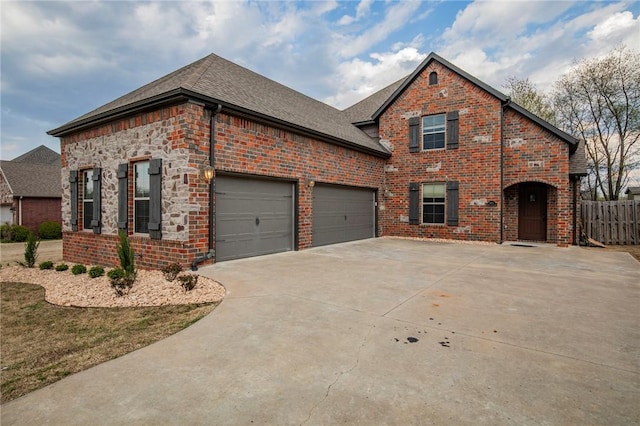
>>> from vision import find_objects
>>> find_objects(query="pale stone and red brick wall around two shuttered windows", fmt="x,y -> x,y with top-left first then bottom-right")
61,103 -> 210,268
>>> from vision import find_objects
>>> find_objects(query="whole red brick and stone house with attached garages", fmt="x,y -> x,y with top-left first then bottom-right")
50,54 -> 584,268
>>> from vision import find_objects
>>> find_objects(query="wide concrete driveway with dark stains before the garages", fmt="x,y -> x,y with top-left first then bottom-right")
2,238 -> 640,425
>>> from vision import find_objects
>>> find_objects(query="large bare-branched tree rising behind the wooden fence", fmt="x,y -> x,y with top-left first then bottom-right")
552,46 -> 640,200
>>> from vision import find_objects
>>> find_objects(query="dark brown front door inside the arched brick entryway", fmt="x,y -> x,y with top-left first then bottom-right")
518,183 -> 547,241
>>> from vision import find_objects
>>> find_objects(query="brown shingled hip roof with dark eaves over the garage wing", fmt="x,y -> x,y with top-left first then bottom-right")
48,54 -> 390,157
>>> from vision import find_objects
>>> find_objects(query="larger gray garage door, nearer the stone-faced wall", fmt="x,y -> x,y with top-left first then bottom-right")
215,176 -> 294,261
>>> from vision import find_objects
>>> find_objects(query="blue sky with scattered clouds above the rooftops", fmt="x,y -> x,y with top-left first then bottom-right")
0,0 -> 640,159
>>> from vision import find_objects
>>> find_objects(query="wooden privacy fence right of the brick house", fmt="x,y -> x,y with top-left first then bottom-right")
581,200 -> 640,244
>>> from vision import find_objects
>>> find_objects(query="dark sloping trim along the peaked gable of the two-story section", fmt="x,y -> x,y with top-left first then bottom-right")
368,52 -> 578,153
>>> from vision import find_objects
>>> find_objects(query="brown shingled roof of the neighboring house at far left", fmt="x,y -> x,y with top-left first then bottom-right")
0,160 -> 62,198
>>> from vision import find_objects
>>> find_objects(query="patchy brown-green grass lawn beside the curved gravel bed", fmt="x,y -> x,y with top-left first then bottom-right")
0,283 -> 216,403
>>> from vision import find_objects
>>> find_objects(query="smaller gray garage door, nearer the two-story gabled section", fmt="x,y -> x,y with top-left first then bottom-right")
313,185 -> 375,247
